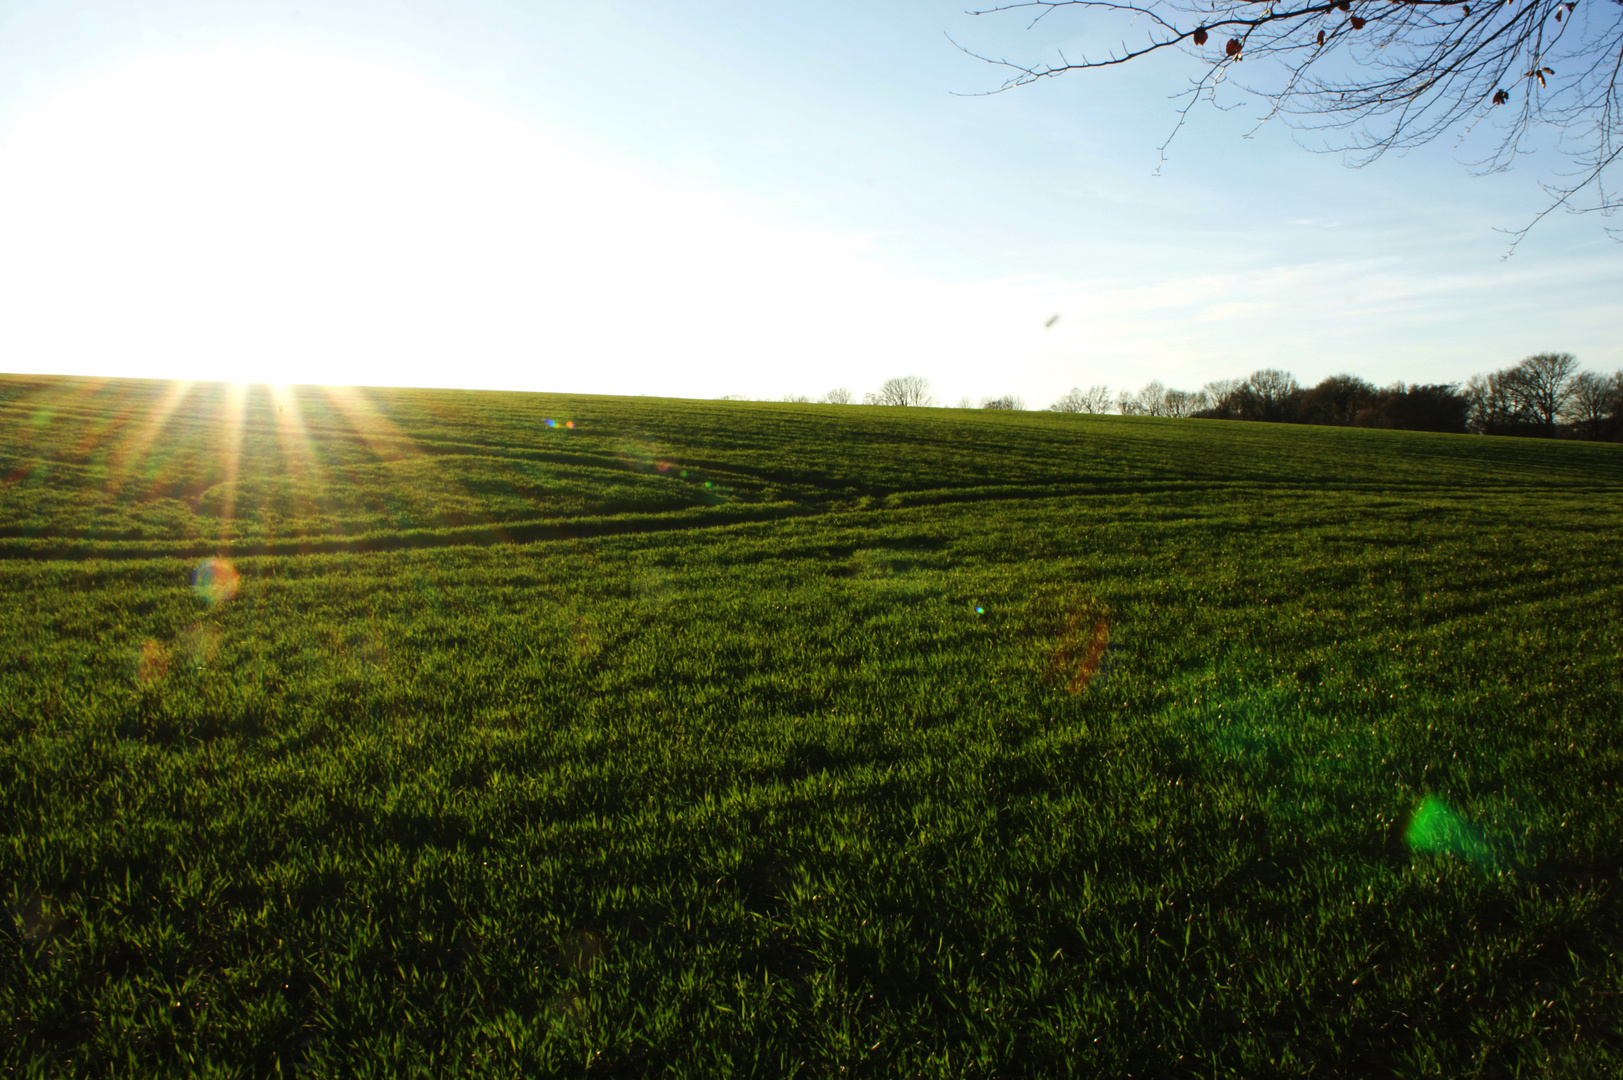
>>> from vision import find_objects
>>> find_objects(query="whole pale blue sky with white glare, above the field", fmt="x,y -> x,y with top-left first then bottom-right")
0,0 -> 1623,408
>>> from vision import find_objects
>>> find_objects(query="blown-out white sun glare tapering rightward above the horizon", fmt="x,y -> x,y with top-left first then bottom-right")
0,47 -> 1084,393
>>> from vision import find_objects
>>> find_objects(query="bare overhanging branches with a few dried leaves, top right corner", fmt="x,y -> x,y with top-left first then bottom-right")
953,0 -> 1623,243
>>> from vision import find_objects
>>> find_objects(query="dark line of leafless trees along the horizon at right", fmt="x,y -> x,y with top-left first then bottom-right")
1048,352 -> 1623,442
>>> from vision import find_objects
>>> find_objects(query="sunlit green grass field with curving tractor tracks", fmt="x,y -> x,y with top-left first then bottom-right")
0,377 -> 1623,1078
